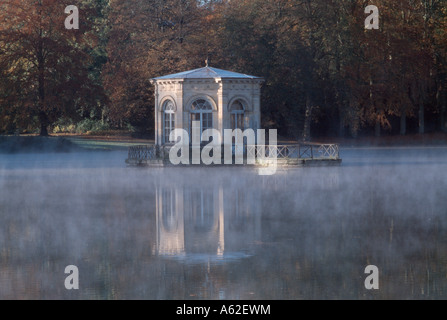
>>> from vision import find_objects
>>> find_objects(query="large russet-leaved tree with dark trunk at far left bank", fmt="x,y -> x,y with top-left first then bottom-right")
0,0 -> 101,136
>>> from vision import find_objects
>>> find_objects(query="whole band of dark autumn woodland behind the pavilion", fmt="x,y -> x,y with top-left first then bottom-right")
0,0 -> 447,139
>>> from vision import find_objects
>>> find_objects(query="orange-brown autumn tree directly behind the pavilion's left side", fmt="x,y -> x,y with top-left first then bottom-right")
104,0 -> 205,131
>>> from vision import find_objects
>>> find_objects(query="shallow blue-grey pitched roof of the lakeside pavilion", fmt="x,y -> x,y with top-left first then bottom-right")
153,67 -> 262,80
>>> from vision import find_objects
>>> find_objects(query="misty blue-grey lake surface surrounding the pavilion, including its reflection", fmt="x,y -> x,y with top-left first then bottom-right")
0,148 -> 447,300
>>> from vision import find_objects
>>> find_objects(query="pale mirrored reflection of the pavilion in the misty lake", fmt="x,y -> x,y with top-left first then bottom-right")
155,178 -> 261,262
